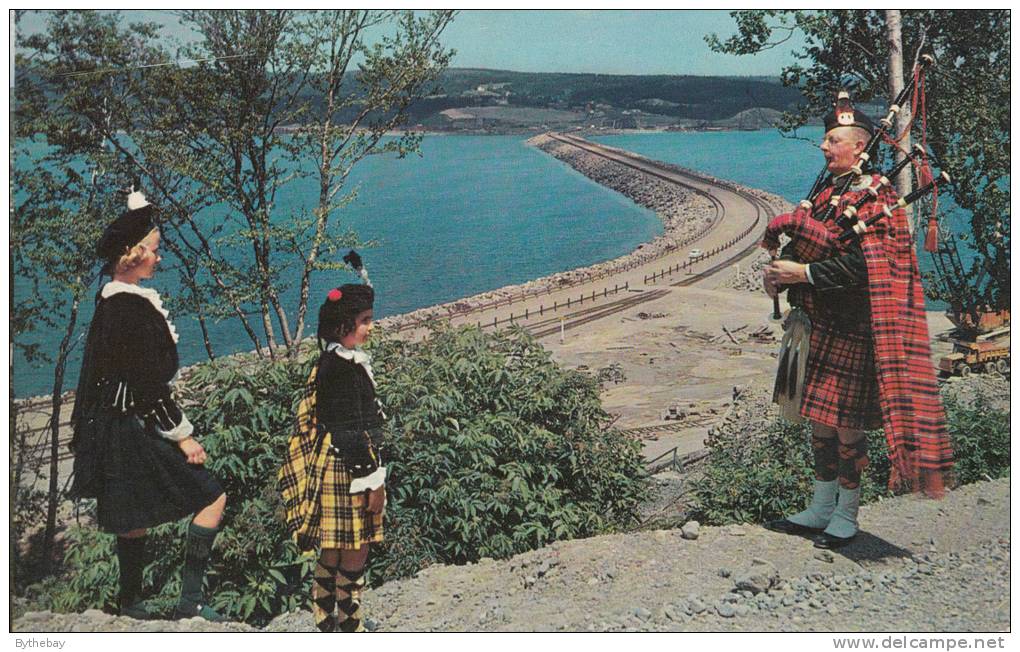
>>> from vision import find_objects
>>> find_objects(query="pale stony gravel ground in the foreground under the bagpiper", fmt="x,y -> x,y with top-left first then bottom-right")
13,479 -> 1010,632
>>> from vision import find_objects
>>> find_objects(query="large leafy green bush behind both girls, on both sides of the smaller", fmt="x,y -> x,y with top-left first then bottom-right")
49,329 -> 645,624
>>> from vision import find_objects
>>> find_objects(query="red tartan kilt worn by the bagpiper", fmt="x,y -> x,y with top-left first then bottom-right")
801,318 -> 882,431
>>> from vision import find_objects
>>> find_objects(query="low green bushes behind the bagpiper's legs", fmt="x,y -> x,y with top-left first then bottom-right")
692,385 -> 1010,524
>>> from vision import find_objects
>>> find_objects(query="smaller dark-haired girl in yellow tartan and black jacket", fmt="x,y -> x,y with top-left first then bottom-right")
279,252 -> 386,632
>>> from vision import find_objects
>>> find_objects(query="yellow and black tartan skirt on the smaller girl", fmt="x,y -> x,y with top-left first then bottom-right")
319,455 -> 383,549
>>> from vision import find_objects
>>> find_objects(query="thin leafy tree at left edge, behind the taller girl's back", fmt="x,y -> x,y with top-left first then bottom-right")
10,11 -> 163,563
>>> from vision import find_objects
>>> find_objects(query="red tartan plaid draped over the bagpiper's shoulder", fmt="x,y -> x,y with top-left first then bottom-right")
762,178 -> 953,498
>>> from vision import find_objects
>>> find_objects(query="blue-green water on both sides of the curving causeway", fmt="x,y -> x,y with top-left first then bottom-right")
13,128 -> 971,396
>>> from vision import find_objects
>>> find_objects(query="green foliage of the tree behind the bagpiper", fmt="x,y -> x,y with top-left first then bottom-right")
706,9 -> 1010,309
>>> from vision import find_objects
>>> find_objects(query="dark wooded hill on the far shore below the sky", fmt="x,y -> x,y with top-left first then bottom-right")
11,68 -> 802,133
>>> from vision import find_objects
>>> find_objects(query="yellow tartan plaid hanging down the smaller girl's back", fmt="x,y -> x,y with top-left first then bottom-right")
277,365 -> 330,551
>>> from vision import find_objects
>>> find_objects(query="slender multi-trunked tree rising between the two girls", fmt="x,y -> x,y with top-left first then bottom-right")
107,10 -> 453,356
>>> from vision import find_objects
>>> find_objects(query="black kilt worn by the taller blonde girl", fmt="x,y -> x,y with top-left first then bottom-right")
71,409 -> 223,533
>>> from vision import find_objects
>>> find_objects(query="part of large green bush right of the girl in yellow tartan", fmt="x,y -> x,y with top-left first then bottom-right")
372,328 -> 646,582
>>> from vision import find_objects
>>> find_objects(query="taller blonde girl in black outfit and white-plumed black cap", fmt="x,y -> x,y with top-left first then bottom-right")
70,192 -> 226,620
